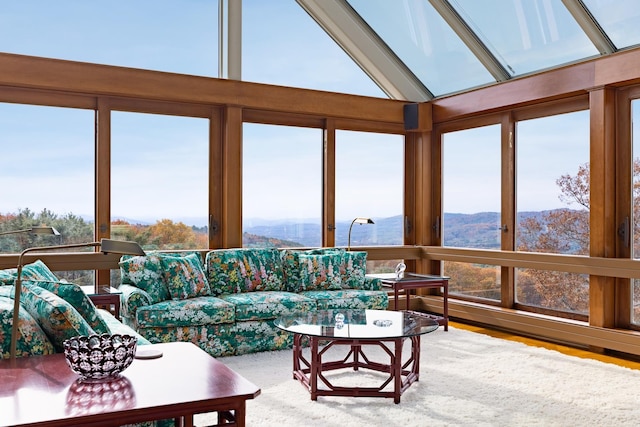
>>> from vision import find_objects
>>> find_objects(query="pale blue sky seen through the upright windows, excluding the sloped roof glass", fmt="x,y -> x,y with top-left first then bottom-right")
0,0 -> 624,226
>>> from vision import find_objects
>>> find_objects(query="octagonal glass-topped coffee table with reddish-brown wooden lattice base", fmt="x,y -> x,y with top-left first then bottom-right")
274,310 -> 439,403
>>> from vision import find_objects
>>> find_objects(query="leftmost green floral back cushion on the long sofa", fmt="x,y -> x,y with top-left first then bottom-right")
118,254 -> 169,303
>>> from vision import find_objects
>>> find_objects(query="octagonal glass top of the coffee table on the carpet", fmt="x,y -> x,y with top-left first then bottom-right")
274,310 -> 439,339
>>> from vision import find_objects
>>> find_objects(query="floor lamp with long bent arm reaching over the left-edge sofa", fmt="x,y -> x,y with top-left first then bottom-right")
10,239 -> 146,360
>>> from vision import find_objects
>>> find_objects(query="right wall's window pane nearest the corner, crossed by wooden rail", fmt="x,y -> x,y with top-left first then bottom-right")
442,125 -> 501,301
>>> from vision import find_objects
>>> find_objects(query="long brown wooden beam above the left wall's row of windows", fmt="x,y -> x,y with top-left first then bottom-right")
0,53 -> 405,126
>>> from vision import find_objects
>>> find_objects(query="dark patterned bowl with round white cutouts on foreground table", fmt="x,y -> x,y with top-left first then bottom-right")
64,334 -> 137,380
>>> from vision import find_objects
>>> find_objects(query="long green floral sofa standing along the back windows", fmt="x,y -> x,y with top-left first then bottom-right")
119,248 -> 388,356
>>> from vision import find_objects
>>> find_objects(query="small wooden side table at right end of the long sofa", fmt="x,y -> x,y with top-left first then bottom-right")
367,273 -> 449,331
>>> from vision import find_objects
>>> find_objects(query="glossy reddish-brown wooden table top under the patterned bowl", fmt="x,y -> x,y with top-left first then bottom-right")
0,342 -> 260,426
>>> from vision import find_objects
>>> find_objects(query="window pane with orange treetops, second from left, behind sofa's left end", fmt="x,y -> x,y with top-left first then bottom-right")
111,112 -> 209,250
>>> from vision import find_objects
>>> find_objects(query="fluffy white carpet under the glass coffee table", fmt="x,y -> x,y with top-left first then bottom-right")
196,327 -> 640,427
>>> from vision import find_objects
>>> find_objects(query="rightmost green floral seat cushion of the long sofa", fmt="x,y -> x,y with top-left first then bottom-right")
301,289 -> 389,310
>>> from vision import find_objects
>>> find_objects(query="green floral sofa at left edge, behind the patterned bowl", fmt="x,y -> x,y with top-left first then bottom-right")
0,260 -> 149,359
